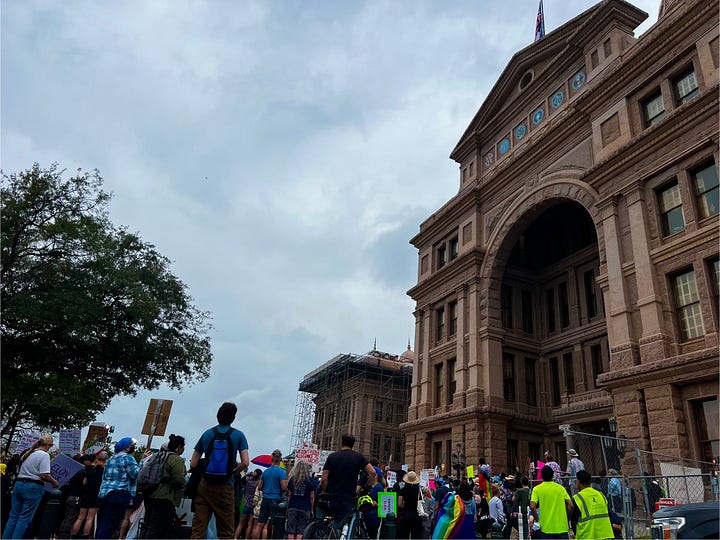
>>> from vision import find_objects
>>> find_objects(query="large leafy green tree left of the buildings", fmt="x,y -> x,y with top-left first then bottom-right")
0,164 -> 212,452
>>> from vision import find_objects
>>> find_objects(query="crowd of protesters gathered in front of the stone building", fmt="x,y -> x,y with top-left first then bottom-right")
2,402 -> 622,540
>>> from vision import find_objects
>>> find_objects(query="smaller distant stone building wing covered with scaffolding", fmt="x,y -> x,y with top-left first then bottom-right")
292,347 -> 414,465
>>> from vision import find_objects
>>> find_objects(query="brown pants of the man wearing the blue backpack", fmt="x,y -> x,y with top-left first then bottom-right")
190,478 -> 235,539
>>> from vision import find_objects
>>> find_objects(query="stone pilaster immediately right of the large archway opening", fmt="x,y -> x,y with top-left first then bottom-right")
598,197 -> 638,369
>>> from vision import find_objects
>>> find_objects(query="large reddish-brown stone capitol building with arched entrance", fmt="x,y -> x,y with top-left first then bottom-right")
401,0 -> 720,473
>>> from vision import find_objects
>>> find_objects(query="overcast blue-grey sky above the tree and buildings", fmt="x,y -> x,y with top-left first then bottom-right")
1,0 -> 660,458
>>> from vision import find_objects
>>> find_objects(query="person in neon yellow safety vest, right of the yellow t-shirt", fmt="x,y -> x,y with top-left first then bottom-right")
570,471 -> 615,540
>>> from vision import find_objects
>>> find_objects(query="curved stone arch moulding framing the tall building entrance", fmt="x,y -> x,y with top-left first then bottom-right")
479,173 -> 605,326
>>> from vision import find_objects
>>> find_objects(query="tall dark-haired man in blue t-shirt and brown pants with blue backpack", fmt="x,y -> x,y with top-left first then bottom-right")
190,402 -> 250,539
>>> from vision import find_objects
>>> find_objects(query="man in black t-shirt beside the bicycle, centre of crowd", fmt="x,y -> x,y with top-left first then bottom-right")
320,434 -> 377,523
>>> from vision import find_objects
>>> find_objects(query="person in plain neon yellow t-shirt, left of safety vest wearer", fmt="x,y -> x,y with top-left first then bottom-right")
530,465 -> 573,538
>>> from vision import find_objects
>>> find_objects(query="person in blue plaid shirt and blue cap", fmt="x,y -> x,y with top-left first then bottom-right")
95,437 -> 140,538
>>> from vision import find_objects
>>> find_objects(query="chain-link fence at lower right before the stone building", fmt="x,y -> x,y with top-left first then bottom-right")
544,429 -> 720,538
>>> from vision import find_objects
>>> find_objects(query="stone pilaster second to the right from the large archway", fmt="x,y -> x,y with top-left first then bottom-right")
626,182 -> 671,362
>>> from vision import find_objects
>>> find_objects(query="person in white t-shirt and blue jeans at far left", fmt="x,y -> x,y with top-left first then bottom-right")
3,435 -> 59,538
